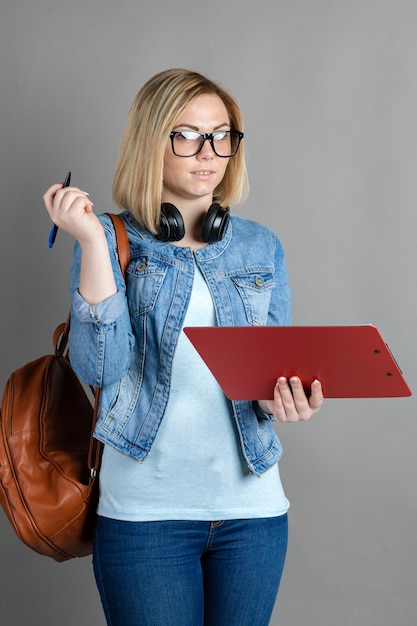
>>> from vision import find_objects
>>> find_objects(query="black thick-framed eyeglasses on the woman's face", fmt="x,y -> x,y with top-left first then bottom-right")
169,129 -> 244,158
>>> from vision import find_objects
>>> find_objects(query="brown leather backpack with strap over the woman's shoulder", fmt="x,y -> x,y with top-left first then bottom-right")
0,215 -> 129,562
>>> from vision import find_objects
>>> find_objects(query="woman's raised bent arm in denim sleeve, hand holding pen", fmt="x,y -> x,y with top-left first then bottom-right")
44,185 -> 134,387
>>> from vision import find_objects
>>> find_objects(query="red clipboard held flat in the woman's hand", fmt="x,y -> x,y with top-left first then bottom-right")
184,324 -> 411,400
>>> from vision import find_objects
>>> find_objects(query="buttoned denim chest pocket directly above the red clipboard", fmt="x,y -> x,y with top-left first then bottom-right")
231,269 -> 275,326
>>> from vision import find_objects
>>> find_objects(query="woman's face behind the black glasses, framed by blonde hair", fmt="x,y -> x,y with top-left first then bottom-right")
162,94 -> 230,209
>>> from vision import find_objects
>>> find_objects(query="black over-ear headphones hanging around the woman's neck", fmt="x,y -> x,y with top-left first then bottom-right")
156,202 -> 230,243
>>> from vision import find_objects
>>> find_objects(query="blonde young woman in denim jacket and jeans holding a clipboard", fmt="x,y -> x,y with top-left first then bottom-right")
44,69 -> 323,626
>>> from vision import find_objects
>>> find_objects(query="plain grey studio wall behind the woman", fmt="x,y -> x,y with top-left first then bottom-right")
0,0 -> 417,626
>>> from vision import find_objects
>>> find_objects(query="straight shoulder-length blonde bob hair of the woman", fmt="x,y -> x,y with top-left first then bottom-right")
113,69 -> 248,234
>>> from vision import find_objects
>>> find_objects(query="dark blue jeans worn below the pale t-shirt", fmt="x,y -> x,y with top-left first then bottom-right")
93,515 -> 288,626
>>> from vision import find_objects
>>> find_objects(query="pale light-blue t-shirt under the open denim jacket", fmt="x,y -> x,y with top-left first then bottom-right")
98,265 -> 289,521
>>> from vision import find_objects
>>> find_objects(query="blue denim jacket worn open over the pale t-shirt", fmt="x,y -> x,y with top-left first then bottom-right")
69,211 -> 291,474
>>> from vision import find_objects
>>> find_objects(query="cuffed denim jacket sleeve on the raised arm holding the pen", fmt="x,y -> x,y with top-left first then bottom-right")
69,216 -> 134,387
